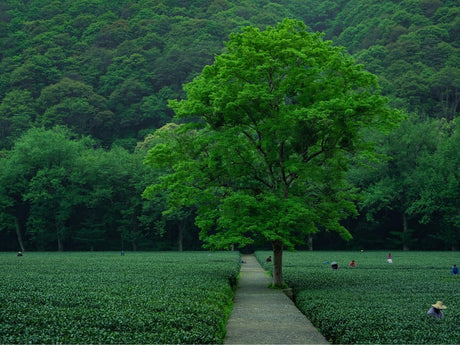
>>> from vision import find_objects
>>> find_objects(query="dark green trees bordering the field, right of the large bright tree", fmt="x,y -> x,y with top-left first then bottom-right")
349,116 -> 460,250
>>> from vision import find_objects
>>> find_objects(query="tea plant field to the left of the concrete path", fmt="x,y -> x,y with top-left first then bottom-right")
0,252 -> 240,344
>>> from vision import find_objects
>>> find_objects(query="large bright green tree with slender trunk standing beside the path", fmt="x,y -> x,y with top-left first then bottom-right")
147,19 -> 401,286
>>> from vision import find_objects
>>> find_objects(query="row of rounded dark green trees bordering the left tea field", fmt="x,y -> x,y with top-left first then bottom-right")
0,127 -> 183,250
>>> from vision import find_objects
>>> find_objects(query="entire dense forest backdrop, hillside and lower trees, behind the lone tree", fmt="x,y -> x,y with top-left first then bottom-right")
0,0 -> 460,250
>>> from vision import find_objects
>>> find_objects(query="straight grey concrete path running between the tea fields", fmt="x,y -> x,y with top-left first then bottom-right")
224,255 -> 329,344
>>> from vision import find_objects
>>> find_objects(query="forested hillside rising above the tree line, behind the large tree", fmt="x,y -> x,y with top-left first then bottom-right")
0,0 -> 459,147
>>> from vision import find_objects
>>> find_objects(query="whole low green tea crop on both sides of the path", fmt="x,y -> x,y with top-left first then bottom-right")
0,252 -> 460,344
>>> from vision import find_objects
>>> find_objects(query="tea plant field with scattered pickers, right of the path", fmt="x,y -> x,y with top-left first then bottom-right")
256,252 -> 460,344
